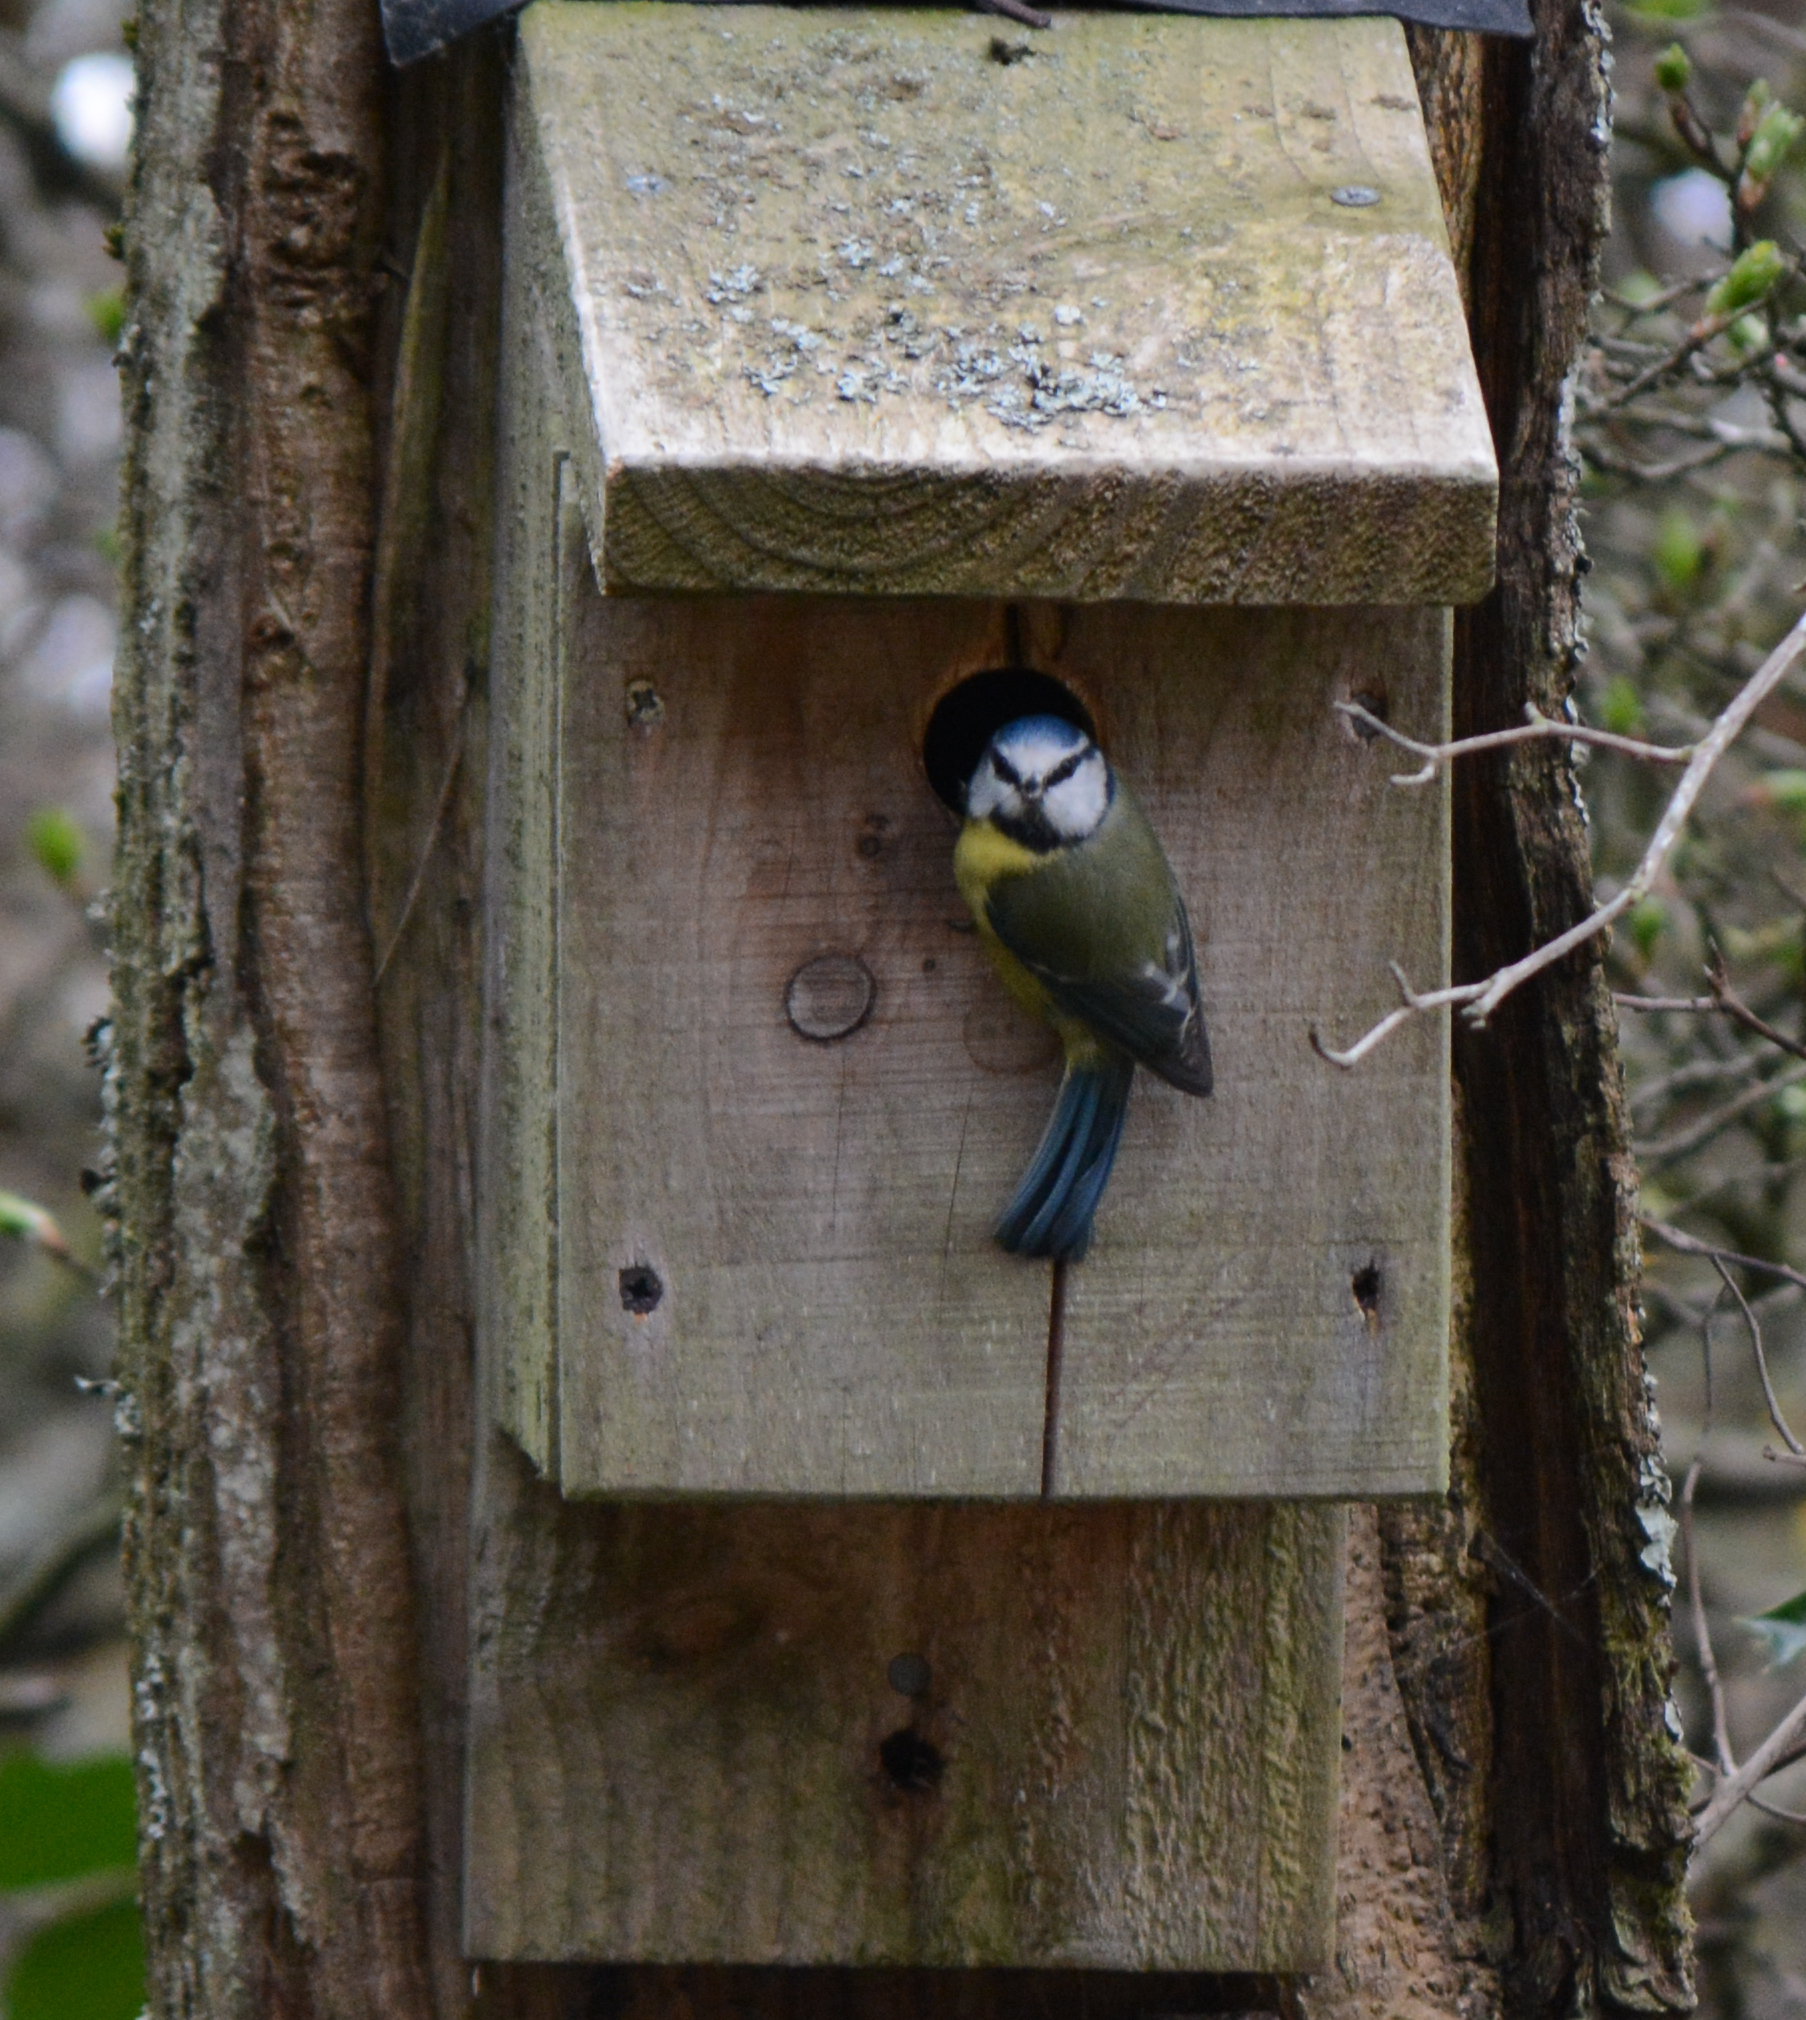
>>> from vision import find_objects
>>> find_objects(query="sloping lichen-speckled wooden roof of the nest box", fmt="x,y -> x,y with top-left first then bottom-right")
519,0 -> 1497,604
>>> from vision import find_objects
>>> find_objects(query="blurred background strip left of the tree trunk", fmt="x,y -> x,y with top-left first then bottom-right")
0,0 -> 143,1987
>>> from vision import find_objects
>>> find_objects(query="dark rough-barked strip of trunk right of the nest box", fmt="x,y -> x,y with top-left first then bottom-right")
1424,0 -> 1691,2012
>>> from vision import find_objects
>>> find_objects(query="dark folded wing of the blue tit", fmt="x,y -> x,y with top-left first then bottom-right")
986,877 -> 1212,1095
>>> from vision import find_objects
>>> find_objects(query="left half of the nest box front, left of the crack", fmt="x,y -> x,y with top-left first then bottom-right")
547,589 -> 1057,1495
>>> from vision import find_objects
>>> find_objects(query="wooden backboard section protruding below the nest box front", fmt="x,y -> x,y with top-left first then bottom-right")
467,1440 -> 1343,1970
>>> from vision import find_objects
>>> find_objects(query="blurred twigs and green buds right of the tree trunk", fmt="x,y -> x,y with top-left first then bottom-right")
1576,0 -> 1806,2020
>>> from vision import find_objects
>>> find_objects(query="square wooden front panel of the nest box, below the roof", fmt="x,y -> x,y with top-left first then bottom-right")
547,569 -> 1448,1497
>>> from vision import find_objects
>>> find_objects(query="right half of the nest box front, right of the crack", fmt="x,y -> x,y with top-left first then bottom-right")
1030,610 -> 1450,1499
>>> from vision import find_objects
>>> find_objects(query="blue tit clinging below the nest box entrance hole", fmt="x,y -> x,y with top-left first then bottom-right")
954,715 -> 1210,1260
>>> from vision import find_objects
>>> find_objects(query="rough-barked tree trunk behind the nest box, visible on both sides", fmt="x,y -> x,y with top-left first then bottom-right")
109,0 -> 1689,2020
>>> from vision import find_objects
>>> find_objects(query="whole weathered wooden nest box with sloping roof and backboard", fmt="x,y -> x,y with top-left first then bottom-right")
469,0 -> 1497,1970
